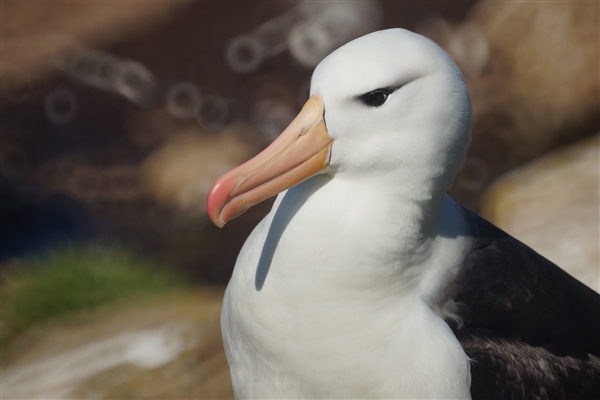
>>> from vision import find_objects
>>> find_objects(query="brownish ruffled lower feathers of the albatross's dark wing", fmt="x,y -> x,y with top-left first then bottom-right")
455,328 -> 600,400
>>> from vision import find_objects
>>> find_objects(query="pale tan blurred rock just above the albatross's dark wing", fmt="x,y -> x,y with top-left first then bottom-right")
482,135 -> 600,292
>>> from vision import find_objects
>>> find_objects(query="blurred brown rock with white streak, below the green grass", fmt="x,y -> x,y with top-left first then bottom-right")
2,289 -> 233,399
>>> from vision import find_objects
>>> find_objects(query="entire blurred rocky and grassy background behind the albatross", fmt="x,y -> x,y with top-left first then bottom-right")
0,0 -> 600,399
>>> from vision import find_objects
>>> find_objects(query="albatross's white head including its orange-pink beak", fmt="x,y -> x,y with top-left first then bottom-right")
207,29 -> 471,226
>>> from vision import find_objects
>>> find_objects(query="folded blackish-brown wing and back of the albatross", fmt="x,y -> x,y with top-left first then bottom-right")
448,209 -> 600,399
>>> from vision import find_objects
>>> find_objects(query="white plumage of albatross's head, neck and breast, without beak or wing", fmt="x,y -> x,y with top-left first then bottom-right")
222,29 -> 471,398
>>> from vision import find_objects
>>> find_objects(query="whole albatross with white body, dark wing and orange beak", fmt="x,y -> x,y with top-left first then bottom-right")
207,29 -> 600,399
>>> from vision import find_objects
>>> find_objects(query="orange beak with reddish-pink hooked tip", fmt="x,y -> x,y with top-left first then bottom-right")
207,96 -> 333,227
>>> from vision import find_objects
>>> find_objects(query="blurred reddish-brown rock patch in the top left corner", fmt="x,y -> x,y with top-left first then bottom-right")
2,1 -> 191,91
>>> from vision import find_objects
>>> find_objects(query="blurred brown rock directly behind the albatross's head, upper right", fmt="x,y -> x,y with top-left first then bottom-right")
432,1 -> 600,208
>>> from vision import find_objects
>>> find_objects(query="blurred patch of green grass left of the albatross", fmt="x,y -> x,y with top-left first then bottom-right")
0,243 -> 184,345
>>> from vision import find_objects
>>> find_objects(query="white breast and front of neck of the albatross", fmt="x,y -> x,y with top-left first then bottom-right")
222,176 -> 470,398
